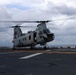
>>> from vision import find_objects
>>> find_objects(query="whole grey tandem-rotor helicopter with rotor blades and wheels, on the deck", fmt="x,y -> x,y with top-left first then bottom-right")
0,17 -> 76,49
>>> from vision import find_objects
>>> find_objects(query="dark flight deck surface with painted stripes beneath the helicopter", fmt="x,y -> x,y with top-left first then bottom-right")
0,49 -> 76,75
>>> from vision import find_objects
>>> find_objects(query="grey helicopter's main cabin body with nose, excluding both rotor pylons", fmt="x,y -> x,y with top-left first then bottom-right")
13,29 -> 54,47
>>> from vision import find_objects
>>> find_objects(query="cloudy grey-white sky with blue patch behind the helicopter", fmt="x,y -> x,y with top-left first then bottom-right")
0,0 -> 76,46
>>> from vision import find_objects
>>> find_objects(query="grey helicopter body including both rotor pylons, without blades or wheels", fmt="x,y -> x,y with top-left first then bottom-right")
13,22 -> 54,47
